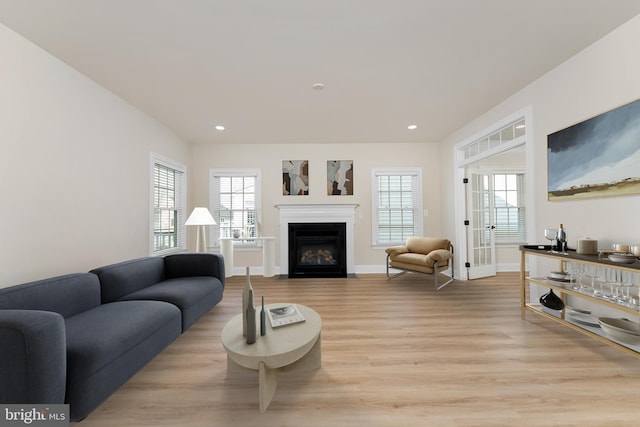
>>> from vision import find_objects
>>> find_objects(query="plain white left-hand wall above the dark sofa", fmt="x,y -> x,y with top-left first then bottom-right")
0,25 -> 191,287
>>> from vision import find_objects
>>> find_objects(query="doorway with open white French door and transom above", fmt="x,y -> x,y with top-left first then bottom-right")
455,110 -> 534,280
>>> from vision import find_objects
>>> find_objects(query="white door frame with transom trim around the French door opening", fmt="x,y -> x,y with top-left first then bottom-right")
453,106 -> 537,280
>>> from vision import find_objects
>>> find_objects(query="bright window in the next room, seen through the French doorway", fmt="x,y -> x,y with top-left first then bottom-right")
492,173 -> 527,243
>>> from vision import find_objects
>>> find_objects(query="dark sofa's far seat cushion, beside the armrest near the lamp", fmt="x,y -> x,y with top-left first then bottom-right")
120,276 -> 224,331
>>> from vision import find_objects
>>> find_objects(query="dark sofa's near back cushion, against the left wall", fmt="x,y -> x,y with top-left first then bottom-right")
0,273 -> 100,318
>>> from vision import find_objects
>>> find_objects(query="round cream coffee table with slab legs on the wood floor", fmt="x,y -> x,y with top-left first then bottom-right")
222,303 -> 322,412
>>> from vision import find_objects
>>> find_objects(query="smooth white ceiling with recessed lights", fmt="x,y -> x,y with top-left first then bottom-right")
0,0 -> 640,143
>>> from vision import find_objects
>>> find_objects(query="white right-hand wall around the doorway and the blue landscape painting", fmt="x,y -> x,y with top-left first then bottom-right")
441,16 -> 640,278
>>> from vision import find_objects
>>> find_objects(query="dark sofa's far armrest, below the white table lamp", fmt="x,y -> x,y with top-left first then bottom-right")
164,253 -> 224,286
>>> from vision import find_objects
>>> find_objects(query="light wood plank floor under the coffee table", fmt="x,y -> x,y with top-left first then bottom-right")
77,273 -> 640,427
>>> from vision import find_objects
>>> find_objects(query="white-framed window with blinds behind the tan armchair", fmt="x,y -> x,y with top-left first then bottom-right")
371,168 -> 423,246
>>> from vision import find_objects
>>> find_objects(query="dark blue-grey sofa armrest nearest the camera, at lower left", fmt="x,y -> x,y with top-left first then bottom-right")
0,310 -> 67,404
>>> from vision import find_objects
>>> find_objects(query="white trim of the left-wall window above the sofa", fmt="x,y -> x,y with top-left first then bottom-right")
149,152 -> 187,256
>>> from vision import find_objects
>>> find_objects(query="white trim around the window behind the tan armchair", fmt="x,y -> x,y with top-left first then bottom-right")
371,166 -> 424,249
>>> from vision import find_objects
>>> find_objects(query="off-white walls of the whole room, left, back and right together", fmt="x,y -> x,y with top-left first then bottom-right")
5,12 -> 640,287
